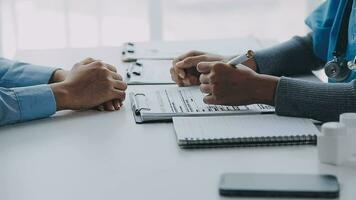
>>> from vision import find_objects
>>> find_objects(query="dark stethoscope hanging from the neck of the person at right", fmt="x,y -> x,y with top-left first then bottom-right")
324,0 -> 356,82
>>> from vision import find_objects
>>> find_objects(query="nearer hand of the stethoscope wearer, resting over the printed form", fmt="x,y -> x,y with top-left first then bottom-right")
197,62 -> 279,105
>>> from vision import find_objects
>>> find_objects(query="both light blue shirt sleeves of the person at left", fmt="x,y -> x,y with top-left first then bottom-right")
0,58 -> 56,126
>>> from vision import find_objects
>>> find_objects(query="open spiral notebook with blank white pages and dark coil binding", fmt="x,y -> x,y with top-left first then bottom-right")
173,114 -> 319,148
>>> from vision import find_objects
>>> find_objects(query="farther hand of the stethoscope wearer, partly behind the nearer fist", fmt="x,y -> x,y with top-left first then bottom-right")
170,51 -> 226,86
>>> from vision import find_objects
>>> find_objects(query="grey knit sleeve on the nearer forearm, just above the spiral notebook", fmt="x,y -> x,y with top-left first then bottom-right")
275,77 -> 356,121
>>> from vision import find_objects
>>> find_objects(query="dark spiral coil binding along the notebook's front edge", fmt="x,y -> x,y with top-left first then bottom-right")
180,135 -> 317,148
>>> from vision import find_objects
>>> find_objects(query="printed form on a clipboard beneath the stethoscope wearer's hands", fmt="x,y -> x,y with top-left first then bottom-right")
130,86 -> 274,122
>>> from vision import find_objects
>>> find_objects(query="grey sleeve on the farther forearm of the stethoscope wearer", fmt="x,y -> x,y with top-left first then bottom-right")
255,35 -> 323,76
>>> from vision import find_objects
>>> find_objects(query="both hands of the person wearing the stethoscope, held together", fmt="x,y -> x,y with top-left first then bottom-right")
171,51 -> 279,105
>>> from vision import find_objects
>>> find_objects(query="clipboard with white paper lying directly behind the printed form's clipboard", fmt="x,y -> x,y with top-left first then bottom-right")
125,60 -> 174,85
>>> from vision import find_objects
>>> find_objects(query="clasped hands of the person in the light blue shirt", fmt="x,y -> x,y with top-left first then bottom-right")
50,59 -> 127,110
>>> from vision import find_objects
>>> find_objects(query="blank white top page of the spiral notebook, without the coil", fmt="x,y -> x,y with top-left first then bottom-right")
173,115 -> 319,140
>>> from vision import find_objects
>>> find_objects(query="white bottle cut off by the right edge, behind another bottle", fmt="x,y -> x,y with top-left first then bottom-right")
340,113 -> 356,157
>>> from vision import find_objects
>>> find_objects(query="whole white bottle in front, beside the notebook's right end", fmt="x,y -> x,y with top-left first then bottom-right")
317,122 -> 349,165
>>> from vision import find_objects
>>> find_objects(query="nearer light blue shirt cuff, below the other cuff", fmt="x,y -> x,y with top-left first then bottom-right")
13,85 -> 57,121
